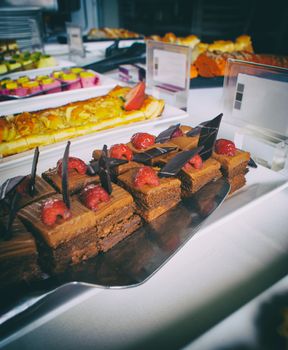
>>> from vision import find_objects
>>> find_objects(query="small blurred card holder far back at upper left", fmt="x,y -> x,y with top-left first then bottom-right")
66,23 -> 85,59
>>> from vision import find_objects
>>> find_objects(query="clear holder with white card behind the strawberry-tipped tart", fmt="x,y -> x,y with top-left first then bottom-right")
146,40 -> 191,109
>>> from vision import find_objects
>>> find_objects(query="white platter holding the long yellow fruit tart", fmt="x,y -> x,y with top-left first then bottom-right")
0,104 -> 189,183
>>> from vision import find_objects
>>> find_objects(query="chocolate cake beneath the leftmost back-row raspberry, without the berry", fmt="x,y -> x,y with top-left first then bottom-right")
42,168 -> 99,194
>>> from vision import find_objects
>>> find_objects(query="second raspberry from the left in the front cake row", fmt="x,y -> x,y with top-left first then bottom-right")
80,184 -> 110,210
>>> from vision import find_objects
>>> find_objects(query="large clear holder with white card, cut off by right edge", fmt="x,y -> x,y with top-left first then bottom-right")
223,60 -> 288,170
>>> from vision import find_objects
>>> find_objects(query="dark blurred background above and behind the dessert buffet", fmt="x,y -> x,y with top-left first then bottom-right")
0,0 -> 288,54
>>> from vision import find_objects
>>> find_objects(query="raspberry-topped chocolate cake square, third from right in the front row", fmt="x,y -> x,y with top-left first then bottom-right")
118,166 -> 181,221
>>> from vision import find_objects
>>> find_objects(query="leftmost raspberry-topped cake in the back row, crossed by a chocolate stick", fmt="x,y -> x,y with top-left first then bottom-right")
42,157 -> 99,194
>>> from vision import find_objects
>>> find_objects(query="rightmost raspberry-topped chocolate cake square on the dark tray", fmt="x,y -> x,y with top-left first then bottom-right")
212,139 -> 250,194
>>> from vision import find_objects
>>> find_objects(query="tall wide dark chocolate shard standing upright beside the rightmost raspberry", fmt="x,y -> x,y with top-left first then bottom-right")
198,113 -> 223,160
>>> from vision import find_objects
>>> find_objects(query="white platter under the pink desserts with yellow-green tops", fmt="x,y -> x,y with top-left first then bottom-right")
0,73 -> 119,115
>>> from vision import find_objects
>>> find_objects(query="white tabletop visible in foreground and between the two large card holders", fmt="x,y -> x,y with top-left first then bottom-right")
0,88 -> 288,350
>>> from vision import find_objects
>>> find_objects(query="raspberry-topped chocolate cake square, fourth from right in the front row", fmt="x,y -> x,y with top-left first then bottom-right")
78,184 -> 142,252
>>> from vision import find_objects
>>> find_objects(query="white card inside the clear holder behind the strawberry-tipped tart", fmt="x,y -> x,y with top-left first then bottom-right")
153,49 -> 187,90
